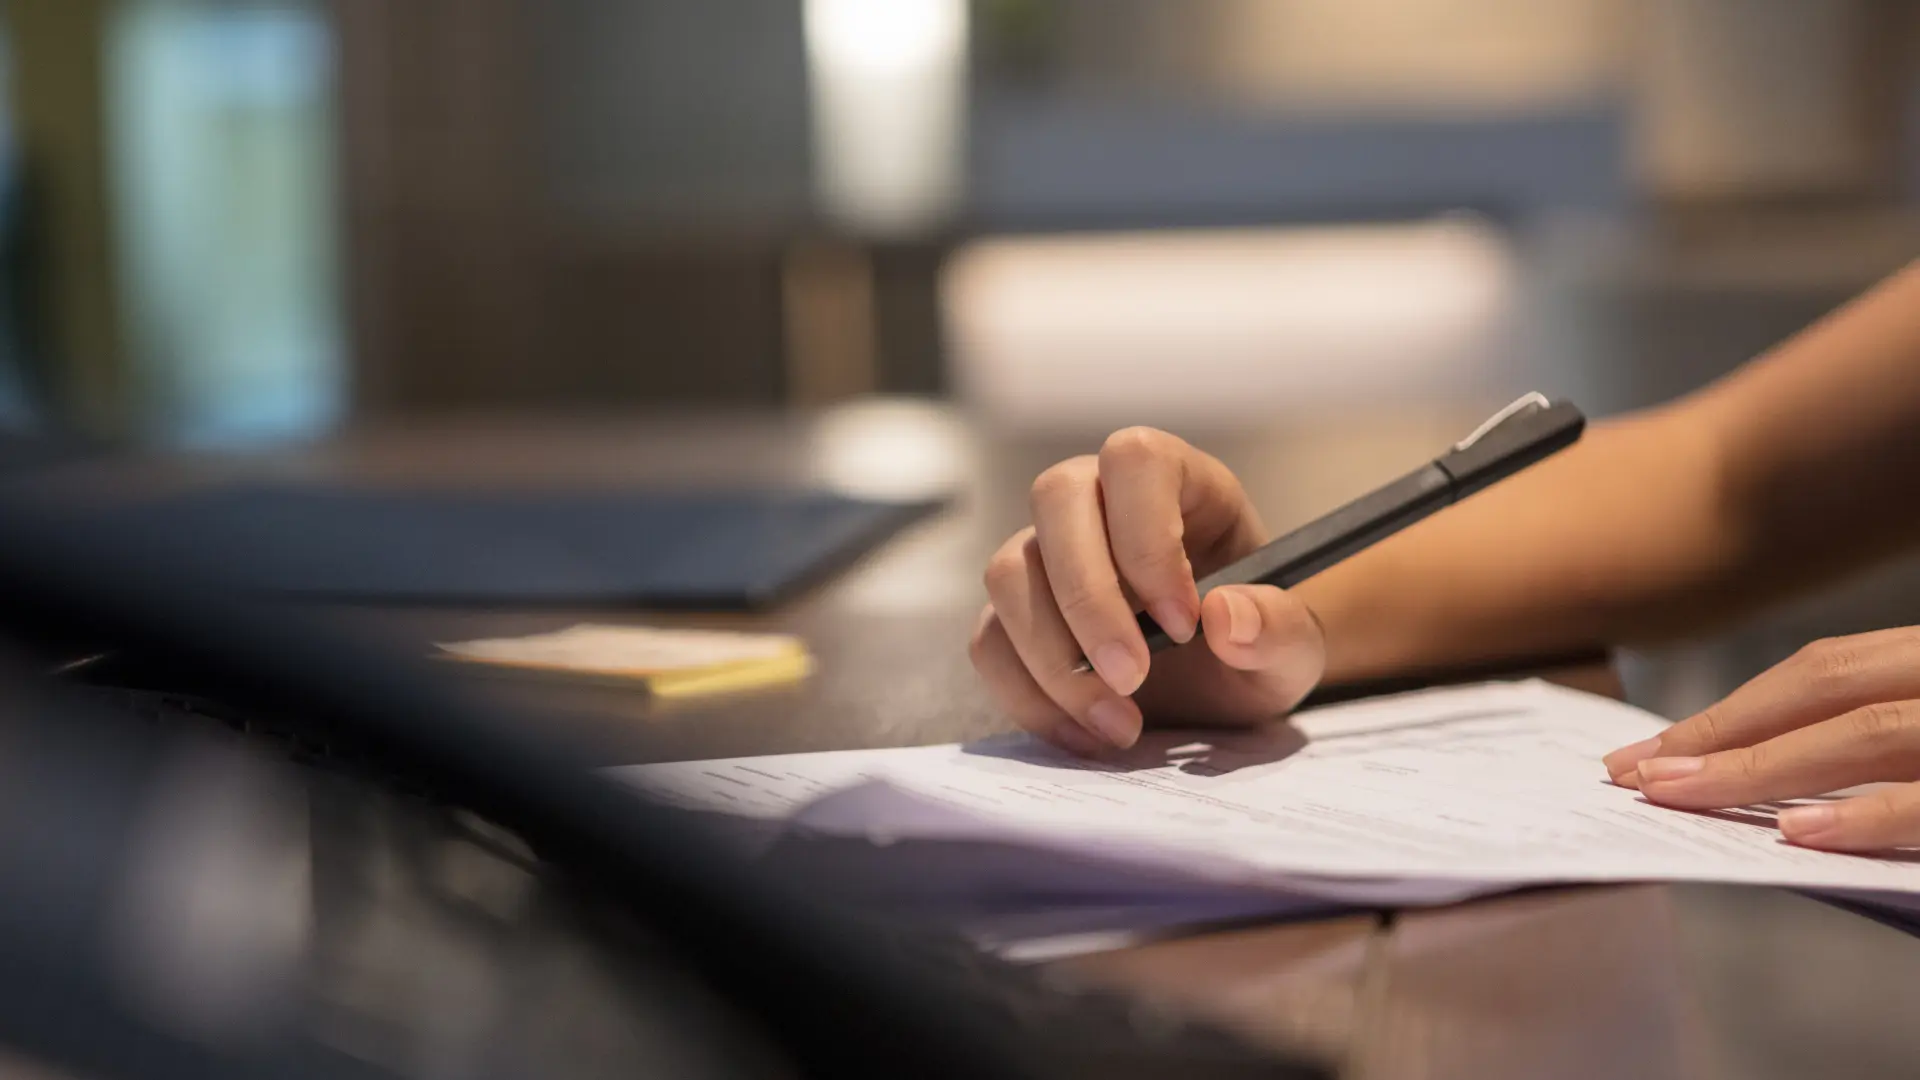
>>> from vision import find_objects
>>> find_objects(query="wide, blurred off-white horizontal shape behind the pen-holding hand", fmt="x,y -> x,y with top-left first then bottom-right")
941,219 -> 1519,429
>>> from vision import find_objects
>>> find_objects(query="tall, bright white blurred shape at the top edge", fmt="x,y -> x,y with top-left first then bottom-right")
806,0 -> 968,233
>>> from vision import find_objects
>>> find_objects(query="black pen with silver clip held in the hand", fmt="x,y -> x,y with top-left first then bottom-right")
1075,394 -> 1586,673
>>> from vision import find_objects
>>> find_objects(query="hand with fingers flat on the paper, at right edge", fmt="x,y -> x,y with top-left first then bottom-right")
1605,626 -> 1920,851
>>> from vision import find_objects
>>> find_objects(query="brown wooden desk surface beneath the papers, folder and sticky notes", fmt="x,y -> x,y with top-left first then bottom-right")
93,404 -> 1920,1080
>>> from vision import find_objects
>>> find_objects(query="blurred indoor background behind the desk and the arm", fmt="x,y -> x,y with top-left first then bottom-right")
11,0 -> 1920,711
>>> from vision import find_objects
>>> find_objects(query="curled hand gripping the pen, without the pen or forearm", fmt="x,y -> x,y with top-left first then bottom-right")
972,429 -> 1327,753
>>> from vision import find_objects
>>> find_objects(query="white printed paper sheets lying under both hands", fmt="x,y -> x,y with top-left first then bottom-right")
616,682 -> 1920,909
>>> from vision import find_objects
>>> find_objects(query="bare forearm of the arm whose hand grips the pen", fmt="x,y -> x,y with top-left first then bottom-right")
1296,261 -> 1920,680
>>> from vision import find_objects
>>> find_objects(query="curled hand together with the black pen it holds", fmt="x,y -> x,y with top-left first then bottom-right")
972,394 -> 1584,753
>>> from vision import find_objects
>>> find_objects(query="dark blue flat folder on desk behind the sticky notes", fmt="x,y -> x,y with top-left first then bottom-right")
111,486 -> 939,609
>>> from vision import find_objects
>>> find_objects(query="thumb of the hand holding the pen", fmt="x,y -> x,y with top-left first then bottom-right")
1200,584 -> 1327,711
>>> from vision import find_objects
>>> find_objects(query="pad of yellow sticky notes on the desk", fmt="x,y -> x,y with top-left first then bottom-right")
438,623 -> 814,698
